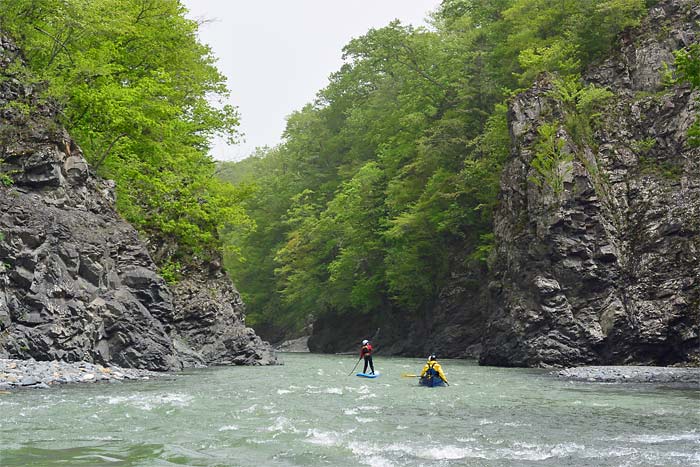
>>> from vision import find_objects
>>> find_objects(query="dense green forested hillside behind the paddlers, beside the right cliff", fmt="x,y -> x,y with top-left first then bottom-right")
219,0 -> 655,338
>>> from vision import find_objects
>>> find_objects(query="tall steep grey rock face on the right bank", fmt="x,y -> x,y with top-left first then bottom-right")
480,0 -> 700,366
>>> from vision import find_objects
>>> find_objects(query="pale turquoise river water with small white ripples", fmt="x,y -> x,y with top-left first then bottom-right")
0,354 -> 700,467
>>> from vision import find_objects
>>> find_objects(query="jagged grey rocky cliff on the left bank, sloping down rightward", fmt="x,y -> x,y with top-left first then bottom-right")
0,35 -> 275,370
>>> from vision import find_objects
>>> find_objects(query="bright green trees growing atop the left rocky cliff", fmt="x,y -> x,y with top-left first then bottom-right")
0,0 -> 250,265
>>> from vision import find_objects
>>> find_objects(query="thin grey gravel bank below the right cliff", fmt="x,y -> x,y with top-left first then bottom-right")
553,366 -> 700,389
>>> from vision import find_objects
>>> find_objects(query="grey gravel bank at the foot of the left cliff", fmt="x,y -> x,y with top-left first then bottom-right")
0,359 -> 163,390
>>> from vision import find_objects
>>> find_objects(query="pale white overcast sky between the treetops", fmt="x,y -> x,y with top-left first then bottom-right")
183,0 -> 440,160
